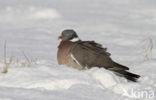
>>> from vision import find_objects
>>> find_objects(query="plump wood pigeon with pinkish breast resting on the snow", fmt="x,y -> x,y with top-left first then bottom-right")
57,29 -> 140,82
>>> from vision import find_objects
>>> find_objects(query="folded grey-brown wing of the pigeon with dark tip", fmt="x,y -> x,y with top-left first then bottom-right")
71,41 -> 129,70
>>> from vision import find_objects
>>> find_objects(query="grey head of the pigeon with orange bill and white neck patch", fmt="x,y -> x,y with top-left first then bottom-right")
58,29 -> 80,42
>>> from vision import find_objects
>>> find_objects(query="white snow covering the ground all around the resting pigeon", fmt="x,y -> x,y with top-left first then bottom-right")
0,0 -> 156,100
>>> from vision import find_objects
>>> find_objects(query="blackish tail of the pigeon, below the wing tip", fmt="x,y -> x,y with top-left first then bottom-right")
112,70 -> 140,82
